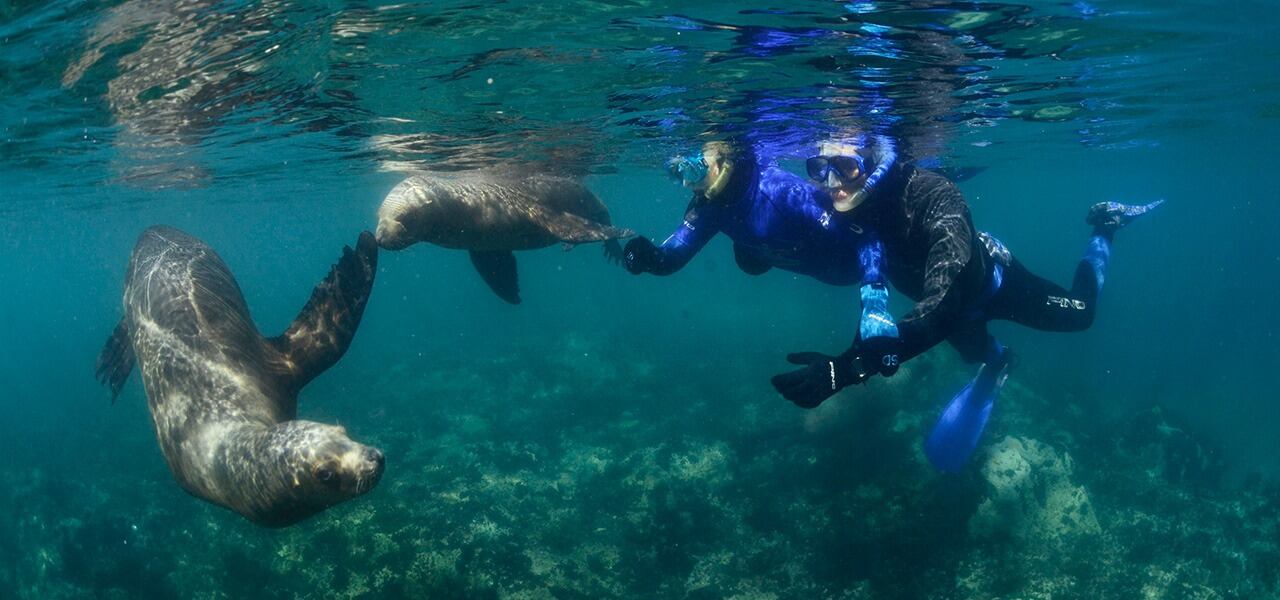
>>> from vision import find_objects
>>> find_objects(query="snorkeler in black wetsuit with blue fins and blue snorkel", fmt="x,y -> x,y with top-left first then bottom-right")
773,143 -> 1162,471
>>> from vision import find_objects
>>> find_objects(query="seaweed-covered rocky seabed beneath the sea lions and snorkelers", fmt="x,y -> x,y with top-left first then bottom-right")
0,334 -> 1280,599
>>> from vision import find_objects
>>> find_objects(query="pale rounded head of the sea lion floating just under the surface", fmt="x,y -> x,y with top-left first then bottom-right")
374,177 -> 461,249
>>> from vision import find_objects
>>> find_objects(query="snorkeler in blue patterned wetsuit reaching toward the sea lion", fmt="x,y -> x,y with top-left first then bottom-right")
623,142 -> 897,373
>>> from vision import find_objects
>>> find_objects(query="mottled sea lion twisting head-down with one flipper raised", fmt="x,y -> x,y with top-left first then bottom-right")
97,226 -> 383,527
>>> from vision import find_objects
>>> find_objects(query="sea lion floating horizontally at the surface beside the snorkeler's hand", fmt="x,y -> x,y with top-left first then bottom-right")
378,171 -> 635,304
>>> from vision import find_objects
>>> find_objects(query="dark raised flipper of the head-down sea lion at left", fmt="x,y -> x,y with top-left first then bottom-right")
269,232 -> 378,393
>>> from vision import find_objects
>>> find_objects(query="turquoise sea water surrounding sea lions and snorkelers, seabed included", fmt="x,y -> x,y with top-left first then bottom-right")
0,1 -> 1280,599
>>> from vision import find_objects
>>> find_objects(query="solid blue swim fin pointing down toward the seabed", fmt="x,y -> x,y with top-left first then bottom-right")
924,361 -> 1007,473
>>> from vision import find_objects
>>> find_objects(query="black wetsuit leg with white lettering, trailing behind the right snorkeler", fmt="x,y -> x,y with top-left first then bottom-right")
987,258 -> 1100,331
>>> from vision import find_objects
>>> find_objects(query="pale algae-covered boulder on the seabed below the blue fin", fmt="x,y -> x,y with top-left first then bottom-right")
969,436 -> 1101,544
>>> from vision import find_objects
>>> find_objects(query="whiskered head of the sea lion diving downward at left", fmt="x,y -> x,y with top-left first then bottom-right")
237,421 -> 385,527
